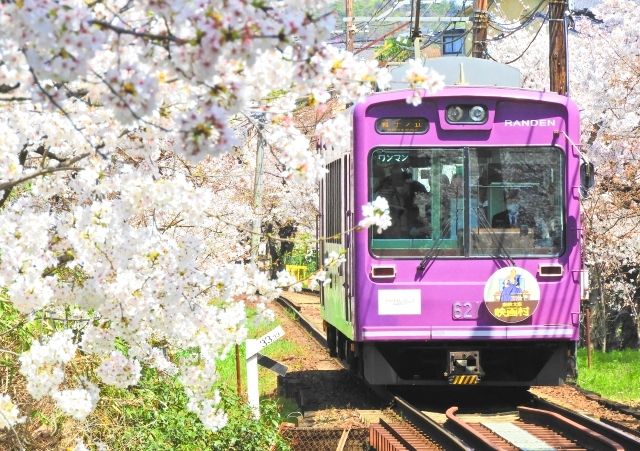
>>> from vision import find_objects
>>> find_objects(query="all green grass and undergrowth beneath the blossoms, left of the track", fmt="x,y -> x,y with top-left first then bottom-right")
0,290 -> 303,451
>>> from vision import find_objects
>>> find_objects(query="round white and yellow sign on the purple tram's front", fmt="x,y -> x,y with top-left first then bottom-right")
484,266 -> 540,323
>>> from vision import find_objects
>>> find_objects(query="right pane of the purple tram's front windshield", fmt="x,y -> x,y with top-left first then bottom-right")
470,148 -> 564,255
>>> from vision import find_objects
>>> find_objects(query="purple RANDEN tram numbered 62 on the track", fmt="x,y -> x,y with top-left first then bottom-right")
320,63 -> 587,387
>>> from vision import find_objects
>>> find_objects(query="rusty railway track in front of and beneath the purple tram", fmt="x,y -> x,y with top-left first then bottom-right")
279,298 -> 640,451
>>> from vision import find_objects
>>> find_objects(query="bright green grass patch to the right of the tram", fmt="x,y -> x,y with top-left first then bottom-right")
578,348 -> 640,405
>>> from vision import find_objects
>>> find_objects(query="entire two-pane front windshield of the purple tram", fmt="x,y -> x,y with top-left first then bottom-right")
369,147 -> 565,258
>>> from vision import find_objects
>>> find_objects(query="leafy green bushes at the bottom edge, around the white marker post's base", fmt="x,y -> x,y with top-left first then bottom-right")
89,369 -> 287,451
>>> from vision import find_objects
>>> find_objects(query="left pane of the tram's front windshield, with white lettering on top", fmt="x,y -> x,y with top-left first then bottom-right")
369,148 -> 465,257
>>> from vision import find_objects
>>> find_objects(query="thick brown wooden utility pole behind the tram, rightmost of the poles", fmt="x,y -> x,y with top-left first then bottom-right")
549,0 -> 569,95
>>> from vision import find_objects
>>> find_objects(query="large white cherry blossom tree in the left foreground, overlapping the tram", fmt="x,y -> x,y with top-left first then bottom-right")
0,0 -> 408,442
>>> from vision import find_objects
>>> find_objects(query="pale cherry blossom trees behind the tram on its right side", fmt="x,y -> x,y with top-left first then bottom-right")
489,0 -> 640,349
